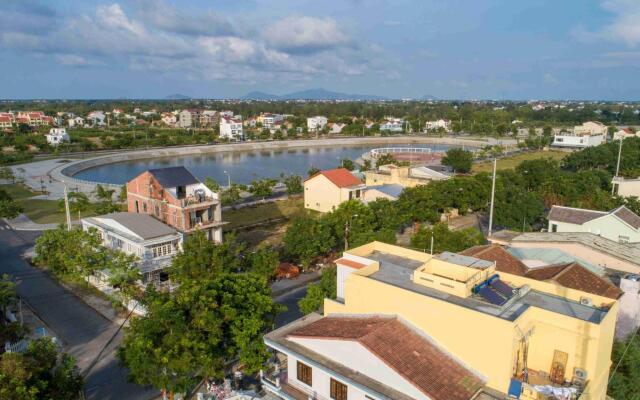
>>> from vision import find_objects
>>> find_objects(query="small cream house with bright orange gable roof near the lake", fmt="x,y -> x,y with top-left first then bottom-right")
304,168 -> 365,212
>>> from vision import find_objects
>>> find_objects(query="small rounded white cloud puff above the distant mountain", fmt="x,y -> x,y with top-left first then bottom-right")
265,17 -> 349,53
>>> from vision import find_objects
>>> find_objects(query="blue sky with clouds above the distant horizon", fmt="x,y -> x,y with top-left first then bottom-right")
0,0 -> 640,101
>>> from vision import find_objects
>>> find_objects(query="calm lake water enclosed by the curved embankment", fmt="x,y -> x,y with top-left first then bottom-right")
74,145 -> 450,185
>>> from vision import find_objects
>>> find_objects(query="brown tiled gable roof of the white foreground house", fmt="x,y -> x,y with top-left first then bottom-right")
289,316 -> 484,400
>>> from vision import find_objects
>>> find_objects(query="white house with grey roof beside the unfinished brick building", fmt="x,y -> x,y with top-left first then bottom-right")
82,212 -> 182,284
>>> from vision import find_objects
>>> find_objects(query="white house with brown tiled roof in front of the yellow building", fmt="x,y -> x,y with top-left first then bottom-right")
261,312 -> 483,400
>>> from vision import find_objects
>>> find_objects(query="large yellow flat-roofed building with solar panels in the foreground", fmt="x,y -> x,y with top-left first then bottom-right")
324,242 -> 618,400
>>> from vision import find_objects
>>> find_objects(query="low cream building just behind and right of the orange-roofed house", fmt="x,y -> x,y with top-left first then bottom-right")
364,164 -> 449,187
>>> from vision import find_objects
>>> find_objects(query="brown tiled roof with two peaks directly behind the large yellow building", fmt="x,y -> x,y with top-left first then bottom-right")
461,244 -> 622,299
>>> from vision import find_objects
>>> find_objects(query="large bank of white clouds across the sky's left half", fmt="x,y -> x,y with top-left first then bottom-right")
0,0 -> 389,82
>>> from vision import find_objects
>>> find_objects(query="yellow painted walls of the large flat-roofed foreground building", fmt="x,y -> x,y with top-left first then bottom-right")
324,242 -> 618,400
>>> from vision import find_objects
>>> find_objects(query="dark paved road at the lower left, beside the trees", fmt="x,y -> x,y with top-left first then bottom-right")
0,220 -> 158,400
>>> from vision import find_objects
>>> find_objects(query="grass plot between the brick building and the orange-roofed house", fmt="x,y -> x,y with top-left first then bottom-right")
222,197 -> 304,230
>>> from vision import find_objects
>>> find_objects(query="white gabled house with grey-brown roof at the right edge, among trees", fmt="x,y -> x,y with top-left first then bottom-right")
548,206 -> 640,243
